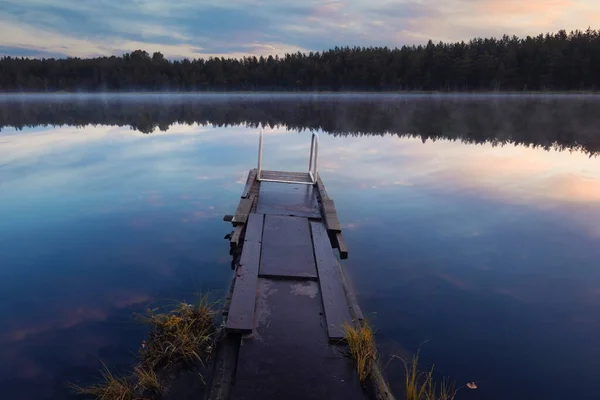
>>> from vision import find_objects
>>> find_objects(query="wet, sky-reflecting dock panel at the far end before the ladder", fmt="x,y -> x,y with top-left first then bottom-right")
256,182 -> 321,218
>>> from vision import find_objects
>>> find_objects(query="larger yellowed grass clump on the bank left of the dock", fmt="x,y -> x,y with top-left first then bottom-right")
140,296 -> 217,371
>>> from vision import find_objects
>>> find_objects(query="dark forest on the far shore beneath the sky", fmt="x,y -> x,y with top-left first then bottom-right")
0,29 -> 600,92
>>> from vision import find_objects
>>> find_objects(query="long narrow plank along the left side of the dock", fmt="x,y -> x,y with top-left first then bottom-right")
225,214 -> 264,333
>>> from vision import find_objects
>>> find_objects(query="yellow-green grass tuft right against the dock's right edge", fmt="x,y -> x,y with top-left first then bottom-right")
344,322 -> 377,384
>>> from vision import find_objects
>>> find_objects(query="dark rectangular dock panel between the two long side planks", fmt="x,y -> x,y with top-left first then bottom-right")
259,215 -> 317,279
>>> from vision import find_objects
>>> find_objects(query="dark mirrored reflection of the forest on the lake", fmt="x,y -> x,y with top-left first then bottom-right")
0,95 -> 600,155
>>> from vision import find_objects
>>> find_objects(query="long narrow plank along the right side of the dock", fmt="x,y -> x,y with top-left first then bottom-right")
310,221 -> 352,340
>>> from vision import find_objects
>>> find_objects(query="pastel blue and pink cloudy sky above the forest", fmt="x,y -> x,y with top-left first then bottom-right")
0,0 -> 600,59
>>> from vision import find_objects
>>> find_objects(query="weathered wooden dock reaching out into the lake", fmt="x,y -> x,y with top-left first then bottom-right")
209,169 -> 367,400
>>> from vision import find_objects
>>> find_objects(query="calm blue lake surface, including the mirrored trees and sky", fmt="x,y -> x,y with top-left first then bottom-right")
0,96 -> 600,400
